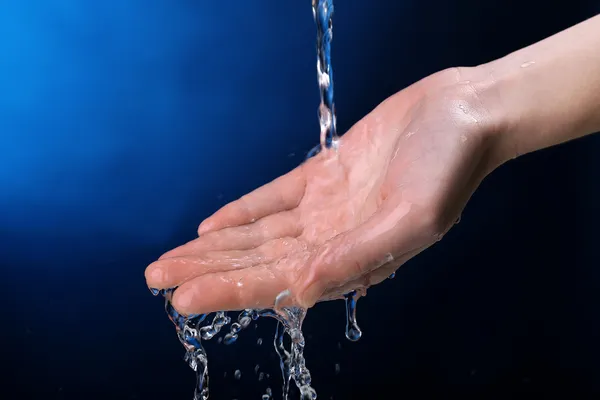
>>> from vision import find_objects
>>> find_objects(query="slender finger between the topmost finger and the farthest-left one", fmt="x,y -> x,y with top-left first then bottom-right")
159,211 -> 302,260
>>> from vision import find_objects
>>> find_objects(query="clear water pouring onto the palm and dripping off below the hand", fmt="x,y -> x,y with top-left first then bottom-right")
151,0 -> 362,400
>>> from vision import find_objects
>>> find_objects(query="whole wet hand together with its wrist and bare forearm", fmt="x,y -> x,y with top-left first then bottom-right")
146,16 -> 600,314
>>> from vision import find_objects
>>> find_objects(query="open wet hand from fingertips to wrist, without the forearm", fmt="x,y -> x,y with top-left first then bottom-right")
146,69 -> 494,314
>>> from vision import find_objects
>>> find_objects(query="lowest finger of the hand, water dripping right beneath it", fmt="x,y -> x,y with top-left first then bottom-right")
172,265 -> 296,315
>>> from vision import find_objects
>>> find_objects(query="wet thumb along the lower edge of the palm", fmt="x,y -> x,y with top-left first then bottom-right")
296,198 -> 434,307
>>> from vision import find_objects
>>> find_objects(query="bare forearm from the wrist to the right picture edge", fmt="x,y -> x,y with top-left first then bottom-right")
478,15 -> 600,162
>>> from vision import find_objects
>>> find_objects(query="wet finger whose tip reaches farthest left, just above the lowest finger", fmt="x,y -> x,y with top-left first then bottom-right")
146,234 -> 298,289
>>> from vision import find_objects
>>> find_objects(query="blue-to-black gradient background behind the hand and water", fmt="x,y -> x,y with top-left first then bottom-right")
0,0 -> 600,400
